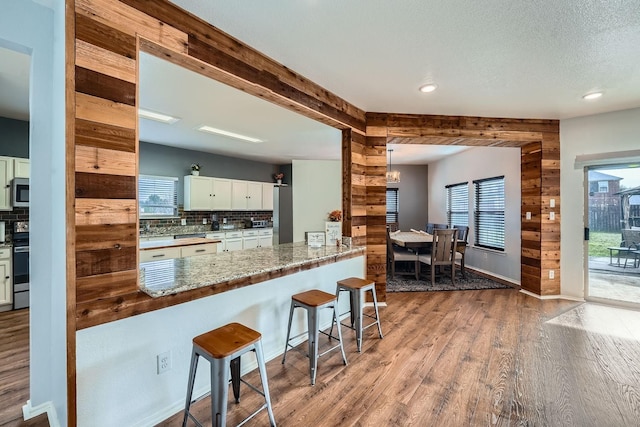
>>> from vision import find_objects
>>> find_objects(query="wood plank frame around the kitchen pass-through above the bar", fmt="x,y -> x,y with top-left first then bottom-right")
67,0 -> 367,329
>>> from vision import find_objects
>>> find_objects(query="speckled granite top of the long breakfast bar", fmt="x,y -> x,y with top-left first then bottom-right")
140,242 -> 366,298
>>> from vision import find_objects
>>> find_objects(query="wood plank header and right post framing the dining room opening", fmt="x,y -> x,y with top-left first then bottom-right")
367,113 -> 560,295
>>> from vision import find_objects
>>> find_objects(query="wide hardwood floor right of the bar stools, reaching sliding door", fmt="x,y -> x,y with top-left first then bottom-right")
160,290 -> 640,427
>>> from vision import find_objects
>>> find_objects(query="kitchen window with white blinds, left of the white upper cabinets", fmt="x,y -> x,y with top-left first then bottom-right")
138,175 -> 178,218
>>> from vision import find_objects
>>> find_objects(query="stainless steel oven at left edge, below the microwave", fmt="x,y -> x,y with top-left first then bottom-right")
11,221 -> 29,310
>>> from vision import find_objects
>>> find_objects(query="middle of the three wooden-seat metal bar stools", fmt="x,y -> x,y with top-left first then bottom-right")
282,289 -> 347,385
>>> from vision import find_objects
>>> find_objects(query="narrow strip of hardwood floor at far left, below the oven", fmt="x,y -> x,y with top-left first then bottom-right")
0,309 -> 49,427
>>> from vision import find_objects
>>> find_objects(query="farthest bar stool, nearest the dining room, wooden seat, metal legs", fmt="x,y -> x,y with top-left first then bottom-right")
329,277 -> 382,352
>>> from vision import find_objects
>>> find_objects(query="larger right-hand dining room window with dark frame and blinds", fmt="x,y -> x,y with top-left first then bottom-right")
473,176 -> 504,251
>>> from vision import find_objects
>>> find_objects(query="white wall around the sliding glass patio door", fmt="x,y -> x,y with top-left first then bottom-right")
560,108 -> 640,298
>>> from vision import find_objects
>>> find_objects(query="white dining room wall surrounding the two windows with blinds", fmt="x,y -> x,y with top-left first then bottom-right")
429,147 -> 521,283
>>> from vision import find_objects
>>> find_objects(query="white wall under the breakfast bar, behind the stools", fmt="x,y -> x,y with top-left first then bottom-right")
77,256 -> 362,427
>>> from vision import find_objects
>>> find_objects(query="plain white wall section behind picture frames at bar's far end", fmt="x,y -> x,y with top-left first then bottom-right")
292,160 -> 342,242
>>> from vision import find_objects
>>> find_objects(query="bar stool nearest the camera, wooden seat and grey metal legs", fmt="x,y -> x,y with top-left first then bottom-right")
182,323 -> 276,427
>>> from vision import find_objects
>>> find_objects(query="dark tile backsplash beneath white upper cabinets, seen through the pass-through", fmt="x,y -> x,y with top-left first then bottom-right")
140,206 -> 273,234
